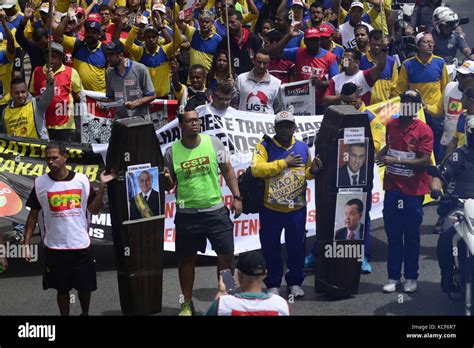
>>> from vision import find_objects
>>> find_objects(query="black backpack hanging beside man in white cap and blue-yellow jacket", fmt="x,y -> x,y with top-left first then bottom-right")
238,134 -> 273,214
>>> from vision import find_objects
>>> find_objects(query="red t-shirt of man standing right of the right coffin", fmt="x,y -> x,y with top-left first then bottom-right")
383,119 -> 433,196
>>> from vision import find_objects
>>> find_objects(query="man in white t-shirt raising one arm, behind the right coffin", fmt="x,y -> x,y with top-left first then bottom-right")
323,43 -> 388,106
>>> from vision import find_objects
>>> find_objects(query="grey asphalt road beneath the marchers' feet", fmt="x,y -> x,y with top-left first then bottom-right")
0,0 -> 474,316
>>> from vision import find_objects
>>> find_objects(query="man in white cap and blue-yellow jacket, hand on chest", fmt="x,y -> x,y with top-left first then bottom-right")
251,111 -> 322,298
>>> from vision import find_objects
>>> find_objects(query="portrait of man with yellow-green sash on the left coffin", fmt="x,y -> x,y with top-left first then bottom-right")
129,170 -> 160,220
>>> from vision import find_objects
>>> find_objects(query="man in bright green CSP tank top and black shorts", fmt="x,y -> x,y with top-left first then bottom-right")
164,109 -> 242,315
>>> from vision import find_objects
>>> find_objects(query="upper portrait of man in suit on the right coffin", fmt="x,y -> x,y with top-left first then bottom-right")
337,143 -> 367,187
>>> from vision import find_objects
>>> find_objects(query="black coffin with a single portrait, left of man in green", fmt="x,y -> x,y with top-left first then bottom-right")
107,117 -> 165,315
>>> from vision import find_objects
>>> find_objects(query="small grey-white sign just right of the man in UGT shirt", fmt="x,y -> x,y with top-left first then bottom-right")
280,80 -> 316,116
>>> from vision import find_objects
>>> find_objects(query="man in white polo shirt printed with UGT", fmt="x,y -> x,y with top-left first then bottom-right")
235,49 -> 281,115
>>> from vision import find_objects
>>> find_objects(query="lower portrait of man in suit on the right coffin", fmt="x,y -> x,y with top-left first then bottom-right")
334,198 -> 364,240
